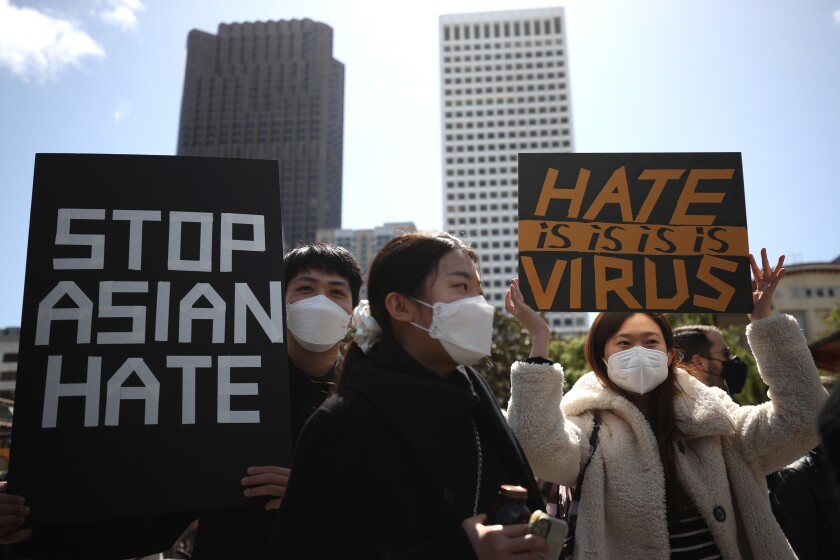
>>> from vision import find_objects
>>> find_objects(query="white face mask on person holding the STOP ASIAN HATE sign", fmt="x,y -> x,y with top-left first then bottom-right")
286,295 -> 350,352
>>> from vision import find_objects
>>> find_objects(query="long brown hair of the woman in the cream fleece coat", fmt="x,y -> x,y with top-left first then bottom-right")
584,311 -> 690,512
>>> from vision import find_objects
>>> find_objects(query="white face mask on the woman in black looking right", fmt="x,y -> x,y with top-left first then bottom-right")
411,296 -> 495,366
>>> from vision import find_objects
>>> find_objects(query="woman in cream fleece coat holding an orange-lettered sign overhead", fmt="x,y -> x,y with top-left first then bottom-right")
507,250 -> 826,560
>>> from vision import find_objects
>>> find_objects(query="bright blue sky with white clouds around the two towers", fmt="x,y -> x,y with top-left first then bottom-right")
0,0 -> 840,327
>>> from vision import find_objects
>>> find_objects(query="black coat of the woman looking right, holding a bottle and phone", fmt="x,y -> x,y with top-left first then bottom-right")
277,340 -> 542,560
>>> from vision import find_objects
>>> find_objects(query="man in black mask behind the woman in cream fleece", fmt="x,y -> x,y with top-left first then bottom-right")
674,325 -> 747,395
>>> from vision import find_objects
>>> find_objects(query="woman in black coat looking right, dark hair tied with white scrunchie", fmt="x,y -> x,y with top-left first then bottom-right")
276,232 -> 547,560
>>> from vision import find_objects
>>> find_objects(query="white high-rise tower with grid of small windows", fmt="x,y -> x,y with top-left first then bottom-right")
440,8 -> 589,334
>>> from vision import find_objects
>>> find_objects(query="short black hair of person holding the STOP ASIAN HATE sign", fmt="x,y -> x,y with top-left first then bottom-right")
283,242 -> 362,307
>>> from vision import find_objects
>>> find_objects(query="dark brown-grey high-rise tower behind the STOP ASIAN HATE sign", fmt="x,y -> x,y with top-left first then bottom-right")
177,19 -> 344,246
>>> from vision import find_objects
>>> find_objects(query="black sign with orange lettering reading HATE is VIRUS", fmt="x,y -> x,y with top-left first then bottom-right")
519,153 -> 752,313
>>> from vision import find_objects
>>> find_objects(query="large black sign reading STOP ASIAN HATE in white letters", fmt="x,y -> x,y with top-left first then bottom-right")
9,154 -> 291,526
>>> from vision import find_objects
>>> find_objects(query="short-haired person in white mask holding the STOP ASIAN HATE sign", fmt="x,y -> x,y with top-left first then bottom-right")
0,243 -> 362,560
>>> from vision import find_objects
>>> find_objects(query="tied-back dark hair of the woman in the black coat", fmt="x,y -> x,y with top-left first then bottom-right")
335,231 -> 478,392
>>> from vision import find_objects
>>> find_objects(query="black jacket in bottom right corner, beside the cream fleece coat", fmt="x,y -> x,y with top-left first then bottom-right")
767,448 -> 840,560
